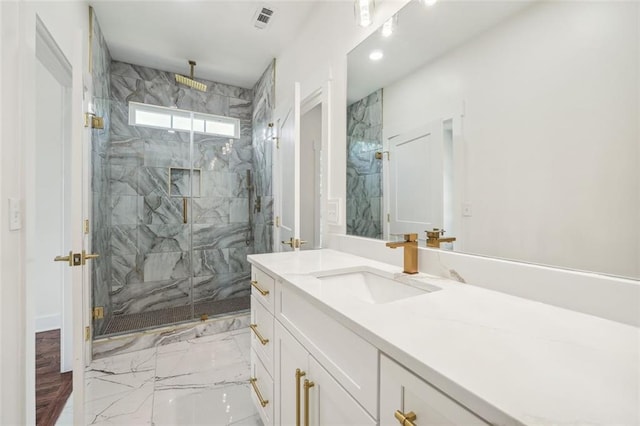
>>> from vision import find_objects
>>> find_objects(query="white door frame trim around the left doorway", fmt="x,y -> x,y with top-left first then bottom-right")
19,13 -> 90,424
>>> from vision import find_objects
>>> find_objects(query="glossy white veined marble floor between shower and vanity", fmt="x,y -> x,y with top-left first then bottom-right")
85,330 -> 262,426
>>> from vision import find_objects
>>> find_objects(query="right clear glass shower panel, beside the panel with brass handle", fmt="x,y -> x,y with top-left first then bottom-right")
190,113 -> 253,319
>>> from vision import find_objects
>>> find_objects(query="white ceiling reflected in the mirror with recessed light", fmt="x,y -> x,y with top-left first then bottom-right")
347,0 -> 535,104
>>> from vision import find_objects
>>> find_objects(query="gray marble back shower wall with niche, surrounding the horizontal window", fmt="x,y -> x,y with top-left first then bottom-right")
108,61 -> 254,320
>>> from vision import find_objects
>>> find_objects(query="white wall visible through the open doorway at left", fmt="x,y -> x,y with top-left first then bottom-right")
32,61 -> 65,332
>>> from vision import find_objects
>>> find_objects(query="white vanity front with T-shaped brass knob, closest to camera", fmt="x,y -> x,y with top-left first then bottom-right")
380,355 -> 489,426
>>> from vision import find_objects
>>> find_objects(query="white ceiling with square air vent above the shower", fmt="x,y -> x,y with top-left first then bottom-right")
90,0 -> 317,88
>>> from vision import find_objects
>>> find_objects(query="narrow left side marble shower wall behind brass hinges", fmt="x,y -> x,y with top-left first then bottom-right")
90,10 -> 111,335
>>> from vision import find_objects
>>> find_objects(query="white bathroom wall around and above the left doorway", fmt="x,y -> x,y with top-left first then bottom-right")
0,1 -> 88,425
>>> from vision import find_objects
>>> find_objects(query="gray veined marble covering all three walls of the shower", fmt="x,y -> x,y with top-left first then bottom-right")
92,54 -> 275,334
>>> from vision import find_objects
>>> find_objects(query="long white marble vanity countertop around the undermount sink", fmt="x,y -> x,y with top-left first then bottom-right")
249,249 -> 640,425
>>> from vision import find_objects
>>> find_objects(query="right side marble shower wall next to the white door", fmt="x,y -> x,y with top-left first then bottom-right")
252,59 -> 276,253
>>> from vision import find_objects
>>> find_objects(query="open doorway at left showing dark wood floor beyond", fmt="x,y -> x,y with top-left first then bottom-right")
30,15 -> 73,425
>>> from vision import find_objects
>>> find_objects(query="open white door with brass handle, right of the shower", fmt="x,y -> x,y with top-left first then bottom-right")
275,83 -> 300,251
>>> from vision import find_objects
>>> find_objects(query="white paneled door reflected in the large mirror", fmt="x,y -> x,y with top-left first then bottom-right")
386,121 -> 444,239
